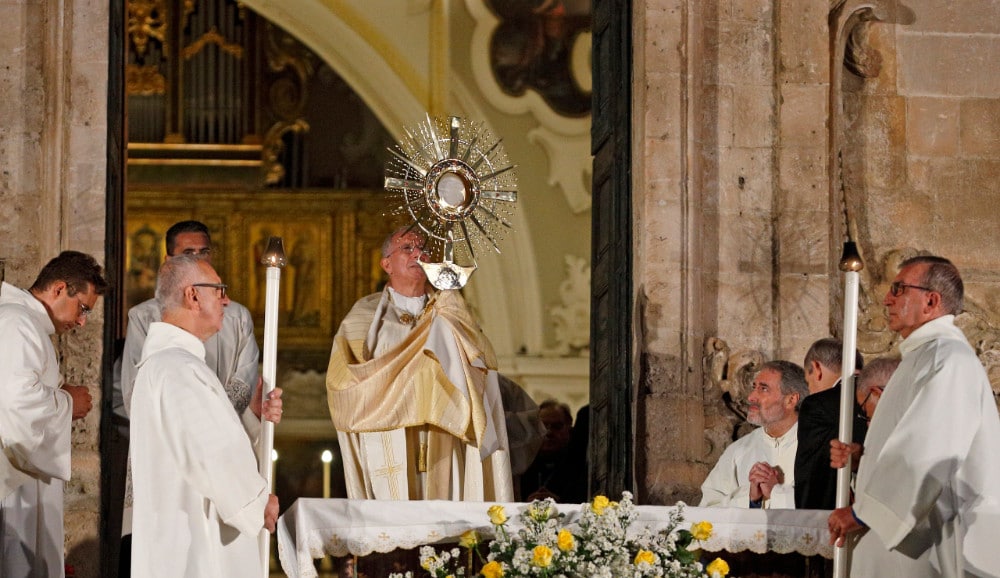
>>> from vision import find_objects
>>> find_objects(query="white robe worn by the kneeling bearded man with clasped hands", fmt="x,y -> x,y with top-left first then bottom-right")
698,422 -> 799,509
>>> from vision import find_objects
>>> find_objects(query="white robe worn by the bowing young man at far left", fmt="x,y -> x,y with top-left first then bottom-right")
0,283 -> 73,578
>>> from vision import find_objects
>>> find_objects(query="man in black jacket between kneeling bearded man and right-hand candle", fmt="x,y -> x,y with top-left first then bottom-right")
795,337 -> 868,510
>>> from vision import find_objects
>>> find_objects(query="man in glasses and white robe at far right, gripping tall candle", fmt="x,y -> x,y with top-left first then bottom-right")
829,256 -> 1000,577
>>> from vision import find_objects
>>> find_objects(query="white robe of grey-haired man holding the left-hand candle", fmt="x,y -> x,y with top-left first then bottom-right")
129,322 -> 268,578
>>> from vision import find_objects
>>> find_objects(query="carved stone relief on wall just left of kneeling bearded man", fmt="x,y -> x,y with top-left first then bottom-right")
702,337 -> 767,464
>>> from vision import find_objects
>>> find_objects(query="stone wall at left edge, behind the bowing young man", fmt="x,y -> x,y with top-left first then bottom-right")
0,0 -> 108,578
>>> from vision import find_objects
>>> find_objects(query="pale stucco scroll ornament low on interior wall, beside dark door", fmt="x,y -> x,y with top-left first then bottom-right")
549,255 -> 590,356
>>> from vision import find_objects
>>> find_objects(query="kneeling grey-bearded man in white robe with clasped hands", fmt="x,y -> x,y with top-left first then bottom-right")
699,360 -> 809,509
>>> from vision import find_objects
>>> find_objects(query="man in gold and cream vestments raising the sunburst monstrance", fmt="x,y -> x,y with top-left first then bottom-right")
326,230 -> 514,501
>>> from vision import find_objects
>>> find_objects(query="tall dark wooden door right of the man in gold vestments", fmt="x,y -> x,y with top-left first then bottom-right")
590,0 -> 634,499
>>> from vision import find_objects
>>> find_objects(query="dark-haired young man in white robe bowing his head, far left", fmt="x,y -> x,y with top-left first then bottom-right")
0,251 -> 108,578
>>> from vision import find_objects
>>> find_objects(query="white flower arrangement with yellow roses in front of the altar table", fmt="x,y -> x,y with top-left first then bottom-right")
390,492 -> 729,578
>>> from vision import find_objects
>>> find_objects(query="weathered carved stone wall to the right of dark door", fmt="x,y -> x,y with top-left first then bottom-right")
633,0 -> 1000,502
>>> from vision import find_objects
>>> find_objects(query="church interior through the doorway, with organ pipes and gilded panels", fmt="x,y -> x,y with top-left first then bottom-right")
123,0 -> 590,516
